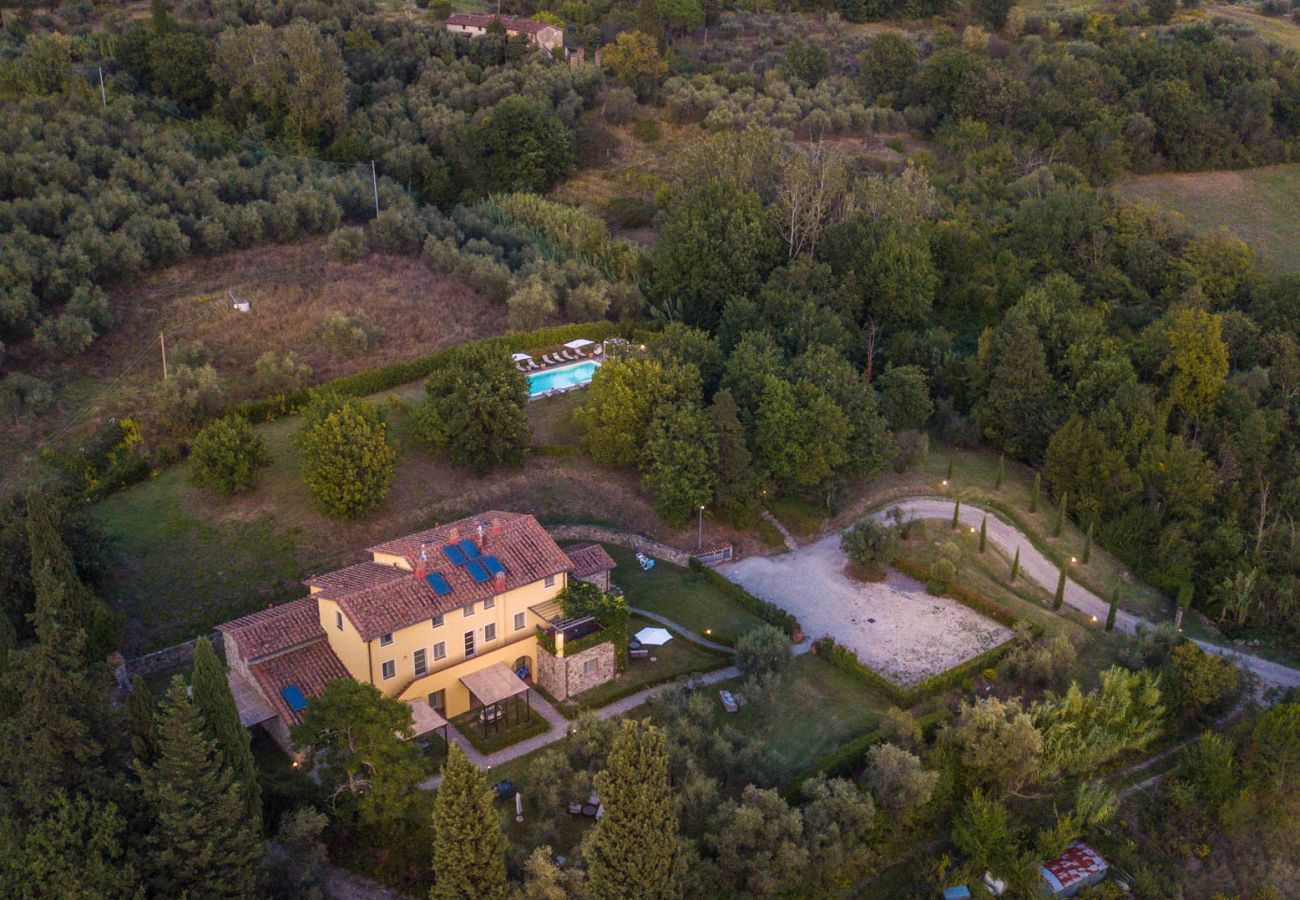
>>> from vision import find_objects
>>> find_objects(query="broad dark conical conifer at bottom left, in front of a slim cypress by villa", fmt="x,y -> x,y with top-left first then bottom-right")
135,676 -> 263,897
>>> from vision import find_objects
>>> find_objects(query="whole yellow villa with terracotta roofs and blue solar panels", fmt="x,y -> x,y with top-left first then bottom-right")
217,511 -> 614,750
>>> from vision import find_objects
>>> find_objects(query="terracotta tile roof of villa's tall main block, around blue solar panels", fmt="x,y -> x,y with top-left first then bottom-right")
313,511 -> 573,641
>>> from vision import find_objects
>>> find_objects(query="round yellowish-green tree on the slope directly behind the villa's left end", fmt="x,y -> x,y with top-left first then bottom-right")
302,395 -> 397,518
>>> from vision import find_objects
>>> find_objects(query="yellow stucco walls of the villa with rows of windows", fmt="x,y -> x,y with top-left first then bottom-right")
316,567 -> 567,717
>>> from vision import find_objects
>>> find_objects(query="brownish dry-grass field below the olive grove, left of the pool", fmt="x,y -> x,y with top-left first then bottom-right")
0,238 -> 506,496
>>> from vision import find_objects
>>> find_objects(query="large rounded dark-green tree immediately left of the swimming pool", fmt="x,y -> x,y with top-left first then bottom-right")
419,346 -> 533,475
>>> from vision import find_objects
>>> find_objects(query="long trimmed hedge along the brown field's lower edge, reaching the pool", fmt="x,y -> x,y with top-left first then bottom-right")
234,321 -> 621,423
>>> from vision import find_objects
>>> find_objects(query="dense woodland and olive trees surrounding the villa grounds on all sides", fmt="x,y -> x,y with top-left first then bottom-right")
0,0 -> 1300,897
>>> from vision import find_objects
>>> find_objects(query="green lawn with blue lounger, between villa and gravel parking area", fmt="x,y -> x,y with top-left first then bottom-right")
605,545 -> 763,644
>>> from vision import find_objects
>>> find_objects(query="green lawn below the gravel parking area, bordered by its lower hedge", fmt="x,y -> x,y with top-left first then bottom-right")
707,653 -> 889,779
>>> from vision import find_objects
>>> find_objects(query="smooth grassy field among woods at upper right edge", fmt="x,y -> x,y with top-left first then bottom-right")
1115,164 -> 1300,272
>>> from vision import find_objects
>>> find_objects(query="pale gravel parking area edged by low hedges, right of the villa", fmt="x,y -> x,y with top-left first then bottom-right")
718,535 -> 1011,687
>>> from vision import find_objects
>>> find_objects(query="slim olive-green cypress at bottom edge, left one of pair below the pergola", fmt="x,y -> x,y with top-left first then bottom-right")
429,744 -> 506,900
